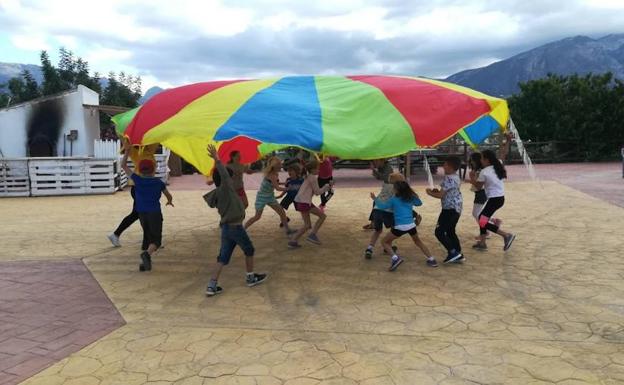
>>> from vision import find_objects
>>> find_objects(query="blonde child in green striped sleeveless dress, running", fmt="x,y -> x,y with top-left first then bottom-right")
245,156 -> 295,235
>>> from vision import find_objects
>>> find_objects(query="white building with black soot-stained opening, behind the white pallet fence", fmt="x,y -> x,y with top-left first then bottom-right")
0,85 -> 100,158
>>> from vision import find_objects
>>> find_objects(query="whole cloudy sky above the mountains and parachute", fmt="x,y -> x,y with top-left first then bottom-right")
0,0 -> 624,88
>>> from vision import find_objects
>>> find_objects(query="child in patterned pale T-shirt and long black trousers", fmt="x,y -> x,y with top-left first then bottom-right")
426,156 -> 465,263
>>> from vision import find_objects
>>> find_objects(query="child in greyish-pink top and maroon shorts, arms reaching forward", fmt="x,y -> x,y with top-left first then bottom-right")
288,160 -> 333,249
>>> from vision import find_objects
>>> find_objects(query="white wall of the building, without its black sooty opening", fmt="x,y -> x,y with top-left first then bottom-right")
0,86 -> 100,158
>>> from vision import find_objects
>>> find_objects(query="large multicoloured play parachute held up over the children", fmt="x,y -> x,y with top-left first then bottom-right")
115,76 -> 509,174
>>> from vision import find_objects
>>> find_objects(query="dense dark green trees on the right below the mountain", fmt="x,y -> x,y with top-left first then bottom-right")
509,73 -> 624,160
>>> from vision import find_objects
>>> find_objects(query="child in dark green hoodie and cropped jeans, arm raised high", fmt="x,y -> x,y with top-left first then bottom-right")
204,145 -> 267,297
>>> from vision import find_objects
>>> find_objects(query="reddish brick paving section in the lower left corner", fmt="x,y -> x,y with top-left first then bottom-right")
0,260 -> 124,385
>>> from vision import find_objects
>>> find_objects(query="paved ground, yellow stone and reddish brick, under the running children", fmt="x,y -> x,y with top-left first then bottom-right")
0,164 -> 624,385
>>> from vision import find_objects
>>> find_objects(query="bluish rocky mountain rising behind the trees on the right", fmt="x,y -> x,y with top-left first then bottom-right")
446,34 -> 624,96
